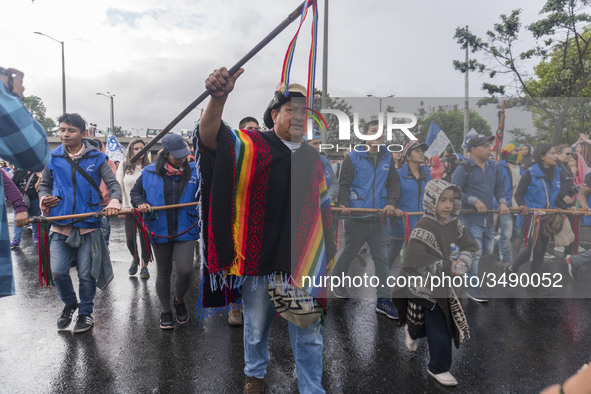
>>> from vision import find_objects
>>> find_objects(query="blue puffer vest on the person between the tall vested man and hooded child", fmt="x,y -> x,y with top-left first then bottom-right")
389,164 -> 431,237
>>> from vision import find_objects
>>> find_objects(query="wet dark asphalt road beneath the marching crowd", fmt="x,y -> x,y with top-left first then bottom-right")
0,213 -> 591,393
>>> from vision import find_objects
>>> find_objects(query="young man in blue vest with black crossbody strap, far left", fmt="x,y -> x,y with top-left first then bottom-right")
38,114 -> 121,333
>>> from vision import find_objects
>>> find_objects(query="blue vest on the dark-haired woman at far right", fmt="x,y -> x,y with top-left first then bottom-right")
517,164 -> 561,228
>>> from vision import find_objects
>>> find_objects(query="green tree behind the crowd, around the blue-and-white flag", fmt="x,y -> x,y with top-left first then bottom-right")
410,104 -> 492,152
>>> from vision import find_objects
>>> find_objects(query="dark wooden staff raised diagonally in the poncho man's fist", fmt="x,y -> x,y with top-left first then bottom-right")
131,1 -> 314,163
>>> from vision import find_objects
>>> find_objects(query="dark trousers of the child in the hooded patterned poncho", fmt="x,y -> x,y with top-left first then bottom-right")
408,298 -> 452,375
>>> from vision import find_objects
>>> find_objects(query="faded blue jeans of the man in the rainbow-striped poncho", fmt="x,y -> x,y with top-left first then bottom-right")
242,276 -> 325,393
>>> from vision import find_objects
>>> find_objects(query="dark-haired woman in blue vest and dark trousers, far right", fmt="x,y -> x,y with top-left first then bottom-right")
506,144 -> 564,296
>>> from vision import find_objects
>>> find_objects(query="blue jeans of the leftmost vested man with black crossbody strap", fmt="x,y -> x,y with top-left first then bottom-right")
49,234 -> 97,315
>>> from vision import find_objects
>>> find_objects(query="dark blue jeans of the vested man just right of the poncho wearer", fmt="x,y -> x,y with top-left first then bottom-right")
332,219 -> 392,298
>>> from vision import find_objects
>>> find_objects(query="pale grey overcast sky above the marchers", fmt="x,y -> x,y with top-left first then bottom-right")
0,0 -> 543,135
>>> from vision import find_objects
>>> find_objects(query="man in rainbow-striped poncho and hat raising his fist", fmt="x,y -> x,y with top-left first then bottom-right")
195,68 -> 335,393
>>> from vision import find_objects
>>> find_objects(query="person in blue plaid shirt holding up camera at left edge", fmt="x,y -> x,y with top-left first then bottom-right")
0,67 -> 49,297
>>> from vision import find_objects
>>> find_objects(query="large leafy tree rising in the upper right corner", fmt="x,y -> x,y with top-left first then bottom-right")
453,0 -> 591,145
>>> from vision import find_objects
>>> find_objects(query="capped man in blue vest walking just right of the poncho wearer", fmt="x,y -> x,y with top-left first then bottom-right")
332,120 -> 400,319
